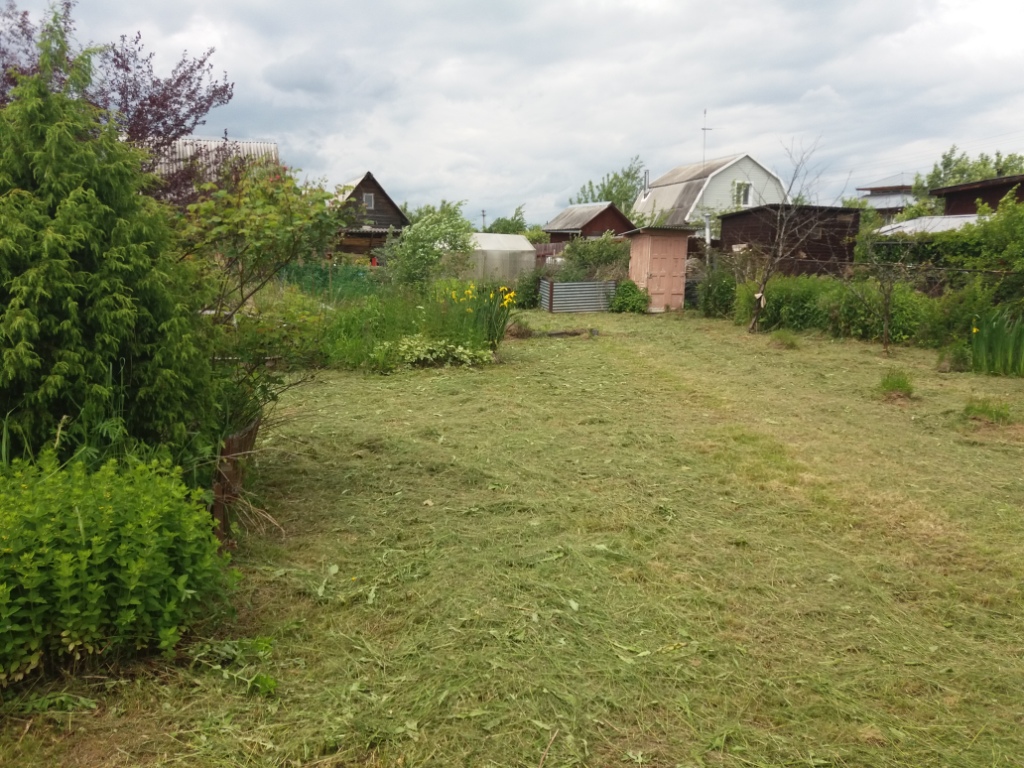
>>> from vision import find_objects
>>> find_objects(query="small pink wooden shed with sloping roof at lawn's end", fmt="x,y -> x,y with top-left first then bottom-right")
627,226 -> 694,312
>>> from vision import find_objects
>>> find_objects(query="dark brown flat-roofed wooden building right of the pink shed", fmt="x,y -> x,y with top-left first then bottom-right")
721,205 -> 860,274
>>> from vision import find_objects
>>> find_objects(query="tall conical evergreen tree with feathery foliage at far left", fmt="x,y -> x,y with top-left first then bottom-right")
0,16 -> 210,455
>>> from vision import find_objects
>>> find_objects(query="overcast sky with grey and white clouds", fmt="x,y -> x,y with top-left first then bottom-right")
19,0 -> 1024,222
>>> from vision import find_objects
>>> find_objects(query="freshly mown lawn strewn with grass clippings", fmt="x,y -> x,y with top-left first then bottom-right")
0,312 -> 1024,768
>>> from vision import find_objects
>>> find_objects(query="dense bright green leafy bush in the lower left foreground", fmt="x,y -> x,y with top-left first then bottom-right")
0,453 -> 226,686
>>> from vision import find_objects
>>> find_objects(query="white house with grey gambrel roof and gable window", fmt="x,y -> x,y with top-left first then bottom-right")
633,155 -> 785,227
